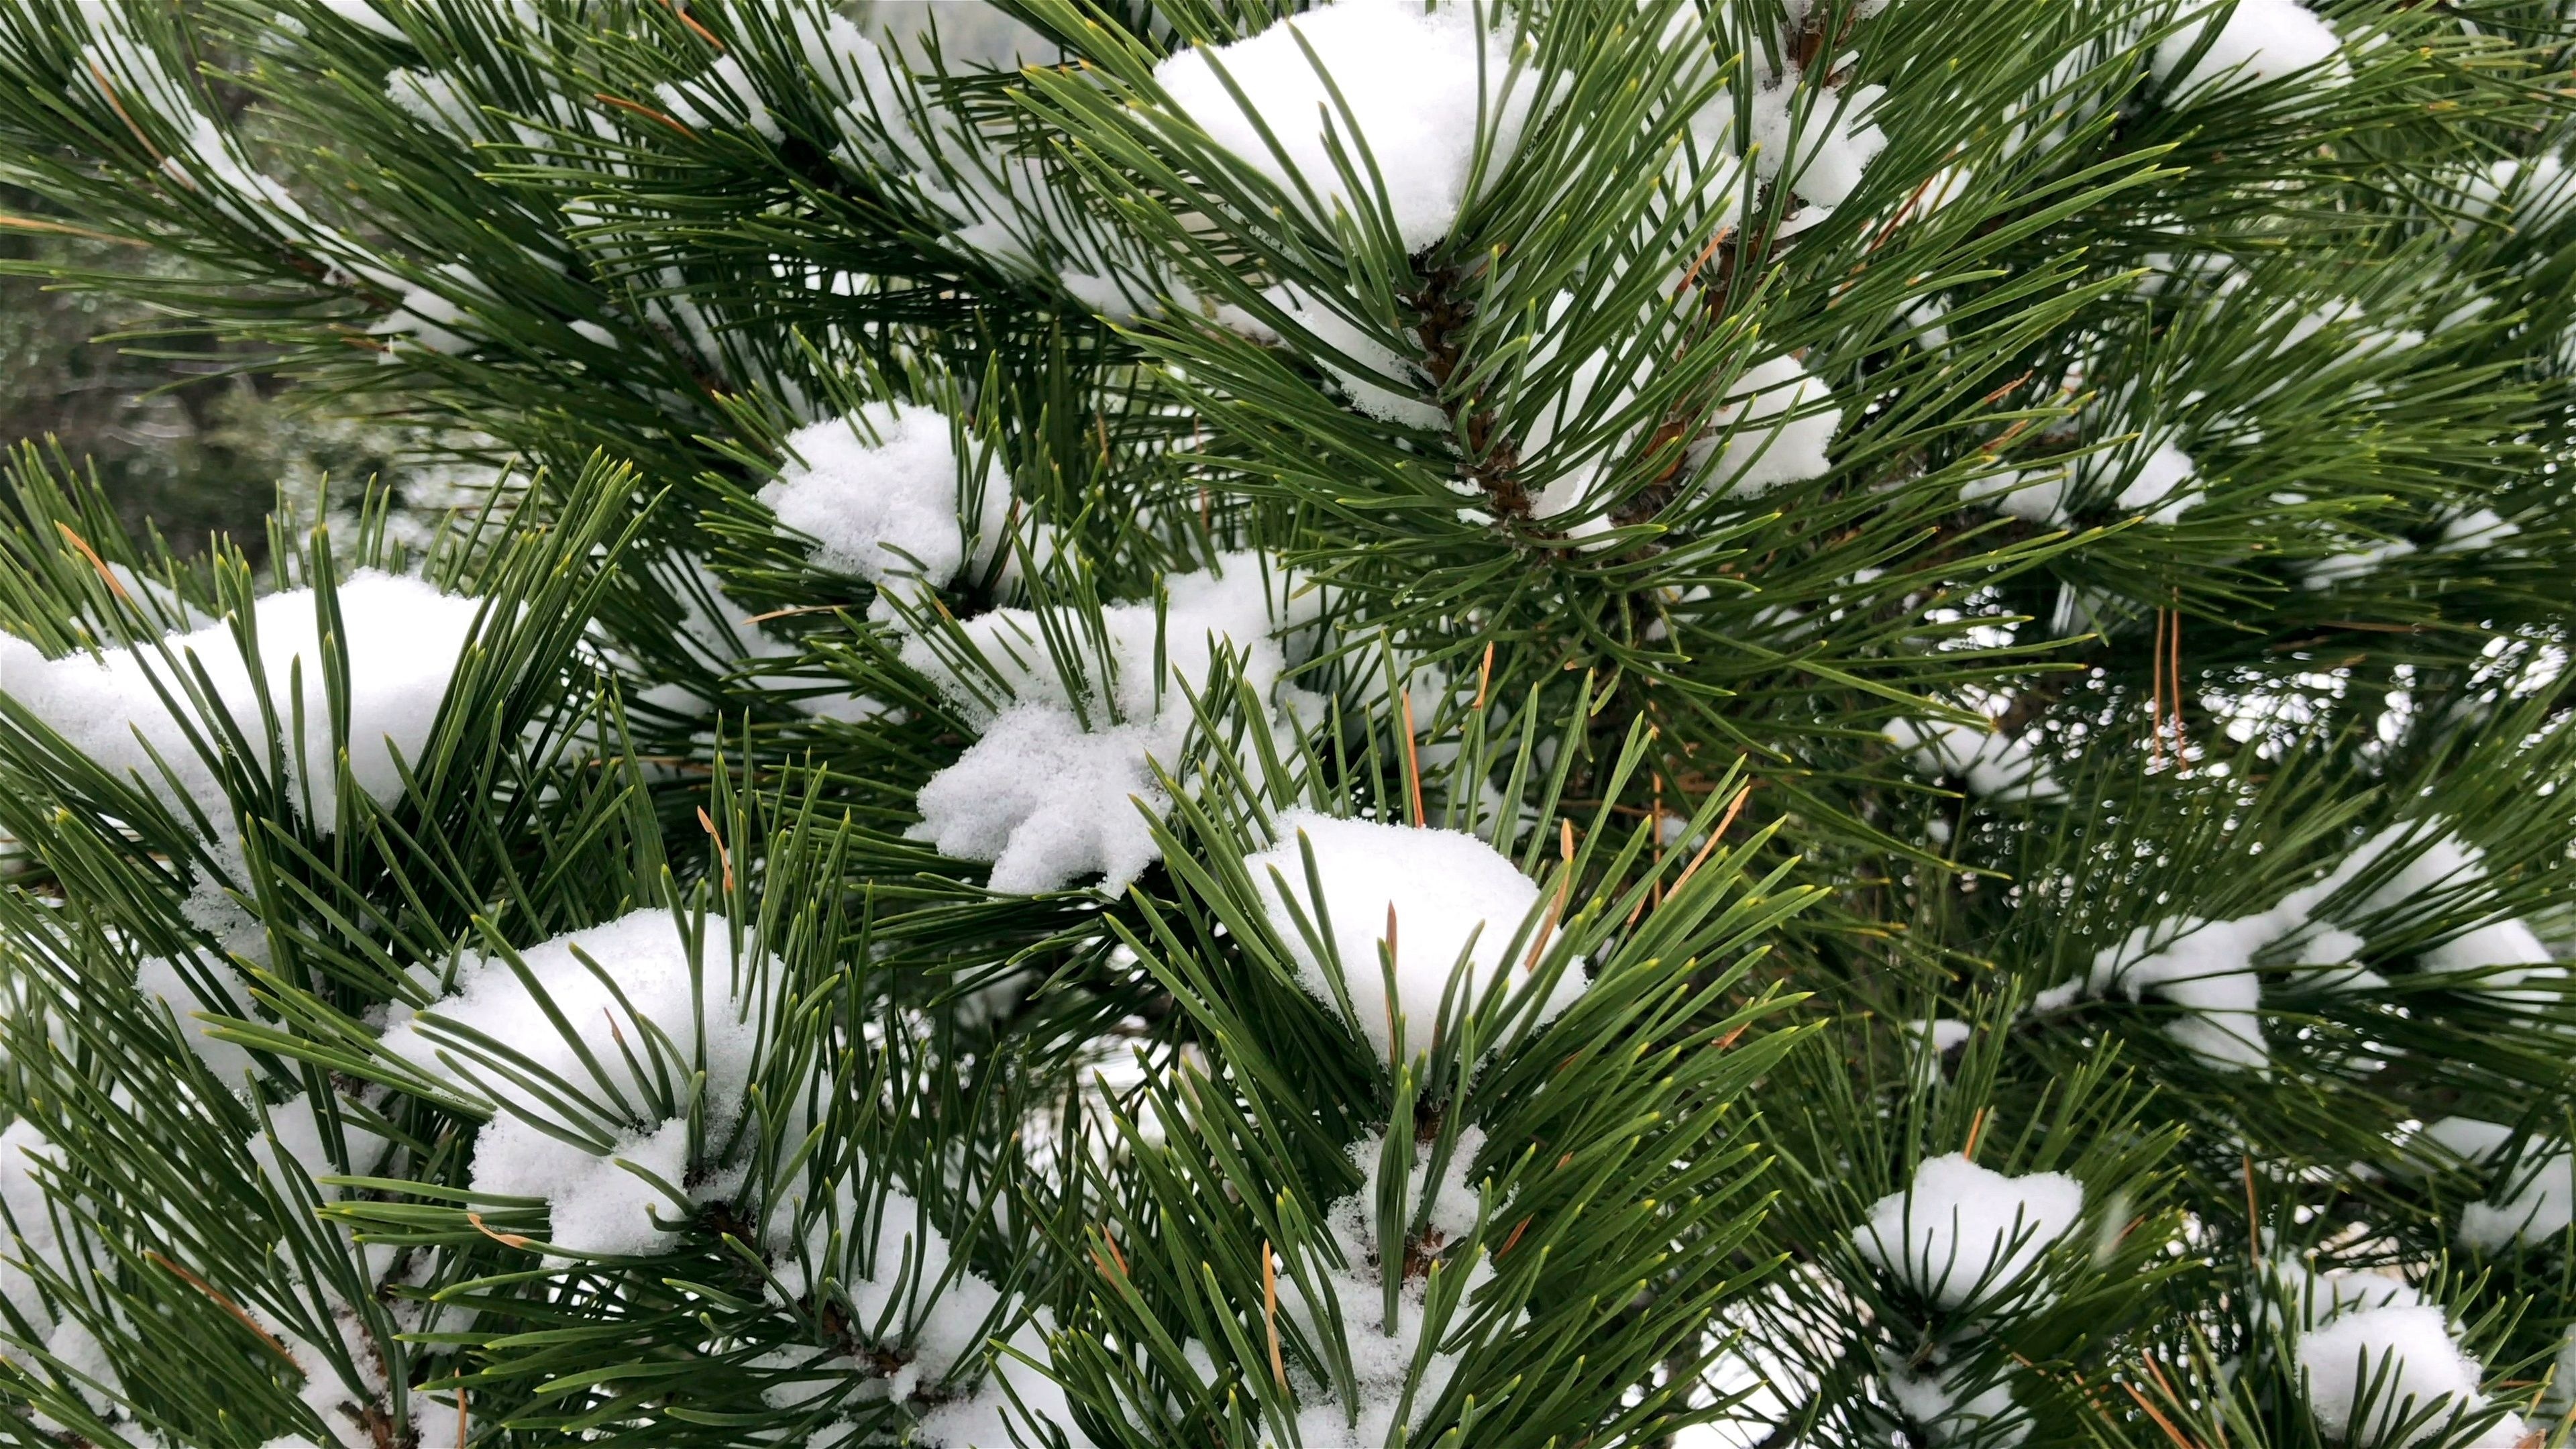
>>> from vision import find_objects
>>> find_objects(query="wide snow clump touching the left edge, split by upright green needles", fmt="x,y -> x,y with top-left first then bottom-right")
0,570 -> 482,830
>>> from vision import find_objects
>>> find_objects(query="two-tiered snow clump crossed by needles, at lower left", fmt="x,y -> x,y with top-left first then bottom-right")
376,908 -> 763,1253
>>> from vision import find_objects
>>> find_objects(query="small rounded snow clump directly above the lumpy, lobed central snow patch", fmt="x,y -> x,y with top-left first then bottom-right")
760,402 -> 1010,588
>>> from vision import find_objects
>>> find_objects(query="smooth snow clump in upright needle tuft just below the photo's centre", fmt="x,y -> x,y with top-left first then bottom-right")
1244,810 -> 1585,1060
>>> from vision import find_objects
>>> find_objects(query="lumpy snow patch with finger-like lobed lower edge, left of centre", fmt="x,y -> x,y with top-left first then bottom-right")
904,554 -> 1306,895
